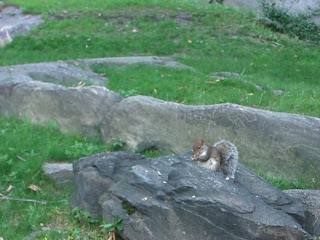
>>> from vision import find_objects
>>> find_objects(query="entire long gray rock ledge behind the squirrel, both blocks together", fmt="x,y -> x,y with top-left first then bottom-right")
0,80 -> 320,181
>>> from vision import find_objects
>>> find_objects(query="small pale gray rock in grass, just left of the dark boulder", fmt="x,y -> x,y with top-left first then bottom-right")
42,163 -> 73,185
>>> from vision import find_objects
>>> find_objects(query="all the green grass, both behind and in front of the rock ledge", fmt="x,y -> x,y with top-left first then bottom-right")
0,0 -> 320,239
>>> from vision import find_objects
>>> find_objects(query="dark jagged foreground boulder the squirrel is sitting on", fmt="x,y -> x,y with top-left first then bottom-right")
70,152 -> 312,240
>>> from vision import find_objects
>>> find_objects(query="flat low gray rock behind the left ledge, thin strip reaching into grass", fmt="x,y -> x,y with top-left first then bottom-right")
0,56 -> 195,86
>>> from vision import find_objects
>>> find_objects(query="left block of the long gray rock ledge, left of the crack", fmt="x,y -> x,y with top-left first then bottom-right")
0,81 -> 122,138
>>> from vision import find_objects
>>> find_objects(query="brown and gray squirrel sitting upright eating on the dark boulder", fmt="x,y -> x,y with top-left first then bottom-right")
191,139 -> 238,180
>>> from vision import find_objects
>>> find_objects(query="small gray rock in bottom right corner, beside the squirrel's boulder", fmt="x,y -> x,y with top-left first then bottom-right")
284,189 -> 320,237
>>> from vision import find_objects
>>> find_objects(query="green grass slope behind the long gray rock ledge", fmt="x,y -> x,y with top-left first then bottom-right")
0,0 -> 320,117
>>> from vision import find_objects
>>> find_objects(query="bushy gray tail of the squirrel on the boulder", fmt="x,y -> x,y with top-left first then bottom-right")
214,140 -> 238,179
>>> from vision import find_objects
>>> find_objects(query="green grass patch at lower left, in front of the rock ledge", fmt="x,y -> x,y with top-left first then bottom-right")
0,116 -> 112,239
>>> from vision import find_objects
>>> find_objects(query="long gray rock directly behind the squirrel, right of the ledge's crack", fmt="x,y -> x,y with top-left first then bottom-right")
101,96 -> 320,181
